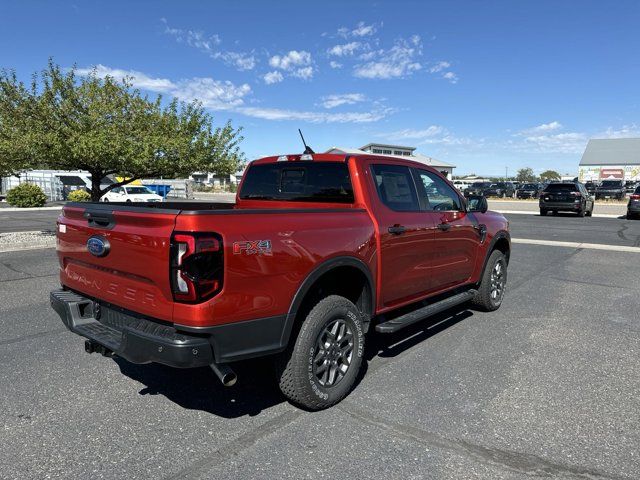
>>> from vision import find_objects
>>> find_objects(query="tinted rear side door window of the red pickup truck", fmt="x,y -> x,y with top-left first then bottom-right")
371,165 -> 420,212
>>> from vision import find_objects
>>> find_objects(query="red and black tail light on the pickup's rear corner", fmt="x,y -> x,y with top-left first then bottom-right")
169,233 -> 224,303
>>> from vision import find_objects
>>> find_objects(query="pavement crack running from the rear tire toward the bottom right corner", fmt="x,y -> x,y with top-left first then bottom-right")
336,401 -> 627,480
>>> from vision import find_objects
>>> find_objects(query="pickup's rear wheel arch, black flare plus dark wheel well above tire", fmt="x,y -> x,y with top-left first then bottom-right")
281,256 -> 376,345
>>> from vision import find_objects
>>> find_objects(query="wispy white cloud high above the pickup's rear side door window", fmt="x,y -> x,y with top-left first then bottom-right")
353,35 -> 422,79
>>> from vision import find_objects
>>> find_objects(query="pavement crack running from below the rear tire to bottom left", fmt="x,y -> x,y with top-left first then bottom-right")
165,410 -> 304,480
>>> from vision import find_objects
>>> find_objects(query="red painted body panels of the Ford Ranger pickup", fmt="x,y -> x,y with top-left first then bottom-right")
58,154 -> 508,327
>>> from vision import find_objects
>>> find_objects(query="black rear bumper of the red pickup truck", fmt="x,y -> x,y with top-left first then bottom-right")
50,290 -> 286,368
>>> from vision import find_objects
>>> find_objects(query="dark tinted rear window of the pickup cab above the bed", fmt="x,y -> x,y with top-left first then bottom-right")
240,162 -> 354,203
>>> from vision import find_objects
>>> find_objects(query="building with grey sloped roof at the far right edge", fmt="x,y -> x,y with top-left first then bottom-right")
578,138 -> 640,182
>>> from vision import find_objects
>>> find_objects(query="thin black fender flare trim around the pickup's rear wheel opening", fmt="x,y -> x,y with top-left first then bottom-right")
280,255 -> 376,347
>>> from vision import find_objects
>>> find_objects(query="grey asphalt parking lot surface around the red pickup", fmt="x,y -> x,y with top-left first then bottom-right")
0,215 -> 640,479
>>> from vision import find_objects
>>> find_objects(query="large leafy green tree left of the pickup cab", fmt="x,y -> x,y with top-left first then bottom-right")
0,60 -> 244,201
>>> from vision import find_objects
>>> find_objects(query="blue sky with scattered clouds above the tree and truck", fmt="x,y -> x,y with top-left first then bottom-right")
0,0 -> 640,174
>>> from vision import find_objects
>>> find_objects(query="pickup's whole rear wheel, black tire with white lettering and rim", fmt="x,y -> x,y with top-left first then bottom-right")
276,295 -> 364,410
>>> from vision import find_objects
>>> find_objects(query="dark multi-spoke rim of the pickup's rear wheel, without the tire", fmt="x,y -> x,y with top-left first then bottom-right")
312,318 -> 353,387
